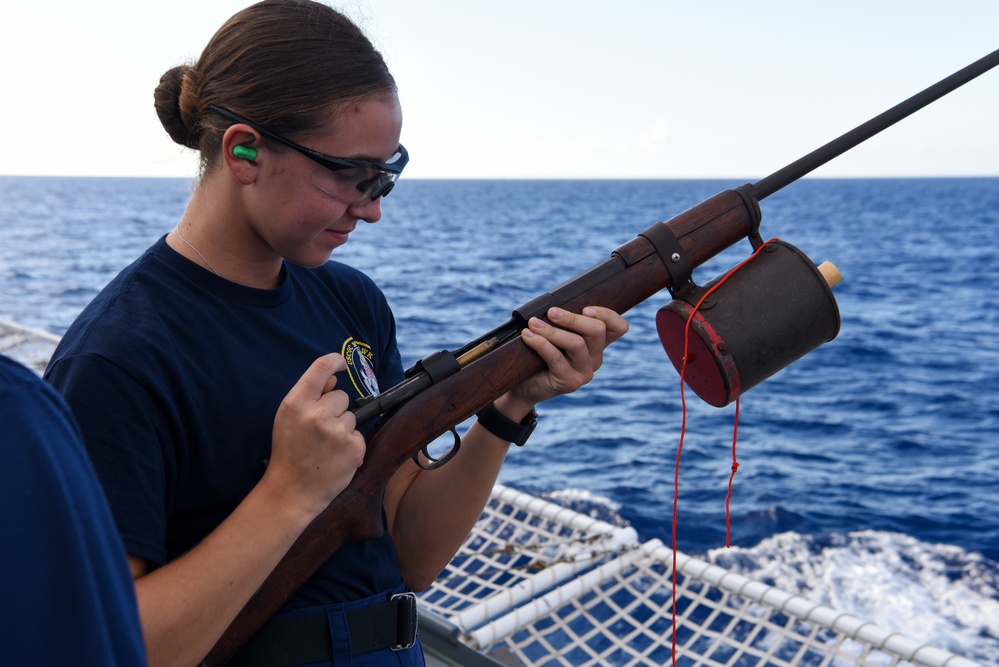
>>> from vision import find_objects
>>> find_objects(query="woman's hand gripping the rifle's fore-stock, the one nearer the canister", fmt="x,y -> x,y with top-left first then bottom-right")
508,306 -> 628,409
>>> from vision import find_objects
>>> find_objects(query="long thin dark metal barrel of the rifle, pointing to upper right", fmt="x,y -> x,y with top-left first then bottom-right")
753,50 -> 999,200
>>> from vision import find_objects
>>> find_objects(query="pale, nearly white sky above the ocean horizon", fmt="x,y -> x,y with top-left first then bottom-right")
0,0 -> 999,179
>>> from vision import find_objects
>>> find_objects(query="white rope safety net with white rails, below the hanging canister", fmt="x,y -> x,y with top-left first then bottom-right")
420,485 -> 976,667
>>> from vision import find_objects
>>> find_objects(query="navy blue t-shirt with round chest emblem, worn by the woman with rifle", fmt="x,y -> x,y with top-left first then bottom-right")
46,238 -> 403,609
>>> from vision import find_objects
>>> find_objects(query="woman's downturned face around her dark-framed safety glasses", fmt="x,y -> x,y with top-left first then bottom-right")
248,94 -> 402,267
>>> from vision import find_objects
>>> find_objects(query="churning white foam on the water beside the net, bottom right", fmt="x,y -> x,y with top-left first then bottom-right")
707,531 -> 999,663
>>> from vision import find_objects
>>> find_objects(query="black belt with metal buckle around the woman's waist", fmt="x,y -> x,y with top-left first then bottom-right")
226,593 -> 417,667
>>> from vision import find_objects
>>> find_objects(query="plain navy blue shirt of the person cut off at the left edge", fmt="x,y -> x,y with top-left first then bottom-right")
0,355 -> 146,665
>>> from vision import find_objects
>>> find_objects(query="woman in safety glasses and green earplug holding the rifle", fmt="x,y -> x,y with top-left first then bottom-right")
47,0 -> 627,665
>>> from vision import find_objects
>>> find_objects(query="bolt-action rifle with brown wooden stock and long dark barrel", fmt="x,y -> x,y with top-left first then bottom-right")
202,50 -> 999,666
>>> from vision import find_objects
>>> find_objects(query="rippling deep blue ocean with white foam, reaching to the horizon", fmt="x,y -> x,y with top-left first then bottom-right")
0,177 -> 999,664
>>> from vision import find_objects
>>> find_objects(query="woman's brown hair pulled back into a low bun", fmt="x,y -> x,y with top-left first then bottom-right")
153,0 -> 396,173
